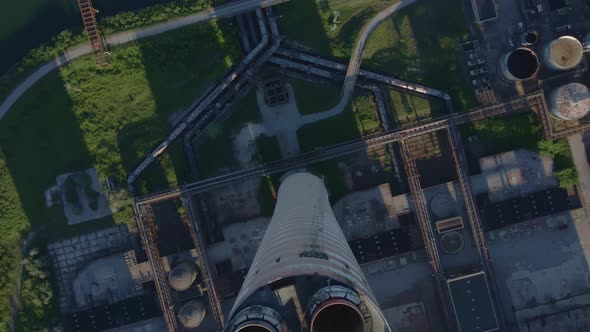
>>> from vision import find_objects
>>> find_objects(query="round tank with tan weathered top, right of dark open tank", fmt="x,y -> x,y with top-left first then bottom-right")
543,36 -> 584,70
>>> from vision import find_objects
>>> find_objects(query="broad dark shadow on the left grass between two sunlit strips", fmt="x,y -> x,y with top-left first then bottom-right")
0,72 -> 112,237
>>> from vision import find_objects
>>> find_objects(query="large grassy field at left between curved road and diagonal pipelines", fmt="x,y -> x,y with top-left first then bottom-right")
0,18 -> 240,330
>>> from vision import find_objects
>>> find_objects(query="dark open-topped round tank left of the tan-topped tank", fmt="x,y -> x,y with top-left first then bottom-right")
500,47 -> 539,81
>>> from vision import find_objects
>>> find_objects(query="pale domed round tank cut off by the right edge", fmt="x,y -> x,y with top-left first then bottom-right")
549,83 -> 590,120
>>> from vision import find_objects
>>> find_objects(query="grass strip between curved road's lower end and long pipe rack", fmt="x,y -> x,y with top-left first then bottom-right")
297,95 -> 380,152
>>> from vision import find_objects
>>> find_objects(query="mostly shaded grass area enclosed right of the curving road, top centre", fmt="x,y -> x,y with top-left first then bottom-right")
366,0 -> 476,110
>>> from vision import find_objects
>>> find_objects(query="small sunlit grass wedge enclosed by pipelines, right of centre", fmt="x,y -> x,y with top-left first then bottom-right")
388,90 -> 446,124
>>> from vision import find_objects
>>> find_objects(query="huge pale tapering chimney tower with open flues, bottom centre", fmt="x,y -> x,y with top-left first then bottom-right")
226,172 -> 391,332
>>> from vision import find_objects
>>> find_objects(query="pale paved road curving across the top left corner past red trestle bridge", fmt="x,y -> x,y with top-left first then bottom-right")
0,0 -> 289,119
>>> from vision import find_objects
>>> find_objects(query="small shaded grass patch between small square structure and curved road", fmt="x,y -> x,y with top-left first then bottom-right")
289,79 -> 340,114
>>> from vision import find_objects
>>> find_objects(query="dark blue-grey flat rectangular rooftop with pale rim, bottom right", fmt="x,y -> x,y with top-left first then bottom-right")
447,271 -> 499,332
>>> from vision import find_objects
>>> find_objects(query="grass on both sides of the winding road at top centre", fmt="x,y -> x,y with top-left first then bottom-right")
279,0 -> 476,110
